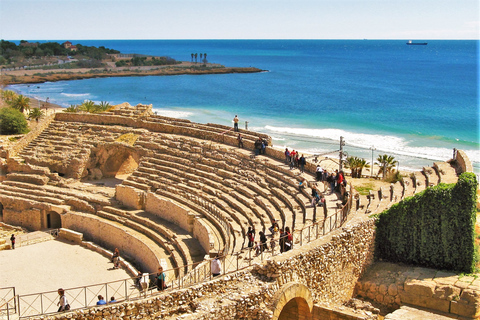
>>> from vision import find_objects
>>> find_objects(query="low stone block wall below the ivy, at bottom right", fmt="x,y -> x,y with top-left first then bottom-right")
355,262 -> 480,319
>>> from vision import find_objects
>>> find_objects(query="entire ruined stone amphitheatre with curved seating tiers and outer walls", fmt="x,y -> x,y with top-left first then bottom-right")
0,104 -> 480,319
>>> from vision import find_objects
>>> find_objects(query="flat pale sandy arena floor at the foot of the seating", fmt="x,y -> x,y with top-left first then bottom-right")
0,240 -> 130,295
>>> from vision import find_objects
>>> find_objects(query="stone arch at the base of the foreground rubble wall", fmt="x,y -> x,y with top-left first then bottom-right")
272,282 -> 313,320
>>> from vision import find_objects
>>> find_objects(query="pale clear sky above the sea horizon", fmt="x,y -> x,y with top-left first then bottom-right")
0,0 -> 480,40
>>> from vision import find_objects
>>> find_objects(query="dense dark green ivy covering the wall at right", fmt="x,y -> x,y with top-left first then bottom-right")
375,172 -> 477,272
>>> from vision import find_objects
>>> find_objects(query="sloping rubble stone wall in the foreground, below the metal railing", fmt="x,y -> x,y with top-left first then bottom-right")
35,216 -> 374,320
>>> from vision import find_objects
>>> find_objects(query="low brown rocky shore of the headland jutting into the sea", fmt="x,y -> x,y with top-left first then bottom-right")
0,62 -> 265,86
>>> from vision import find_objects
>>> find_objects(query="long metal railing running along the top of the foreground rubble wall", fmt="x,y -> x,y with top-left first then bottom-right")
14,194 -> 352,318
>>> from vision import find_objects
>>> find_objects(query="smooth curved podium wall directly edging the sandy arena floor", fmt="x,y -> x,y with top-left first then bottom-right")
62,213 -> 160,272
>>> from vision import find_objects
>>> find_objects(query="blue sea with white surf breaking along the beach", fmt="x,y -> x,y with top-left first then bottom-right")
10,40 -> 480,173
